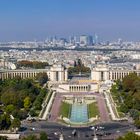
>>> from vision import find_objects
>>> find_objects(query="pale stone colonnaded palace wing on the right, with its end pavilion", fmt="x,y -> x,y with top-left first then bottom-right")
91,64 -> 140,81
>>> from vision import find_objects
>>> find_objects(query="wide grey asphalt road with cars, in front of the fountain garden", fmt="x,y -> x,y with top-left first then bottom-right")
19,121 -> 134,140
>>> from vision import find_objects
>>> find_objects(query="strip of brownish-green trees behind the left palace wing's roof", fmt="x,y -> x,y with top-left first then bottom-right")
17,60 -> 49,69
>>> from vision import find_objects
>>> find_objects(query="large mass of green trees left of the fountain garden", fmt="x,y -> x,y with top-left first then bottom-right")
0,77 -> 47,130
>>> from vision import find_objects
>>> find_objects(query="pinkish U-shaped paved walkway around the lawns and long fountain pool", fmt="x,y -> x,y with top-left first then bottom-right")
48,92 -> 110,122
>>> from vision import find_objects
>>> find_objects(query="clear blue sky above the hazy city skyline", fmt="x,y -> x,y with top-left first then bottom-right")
0,0 -> 140,41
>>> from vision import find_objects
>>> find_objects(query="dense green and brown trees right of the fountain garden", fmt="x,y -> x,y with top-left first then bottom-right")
111,73 -> 140,127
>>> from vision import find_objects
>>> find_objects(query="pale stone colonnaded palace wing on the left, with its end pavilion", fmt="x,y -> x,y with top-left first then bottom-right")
0,65 -> 68,82
